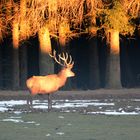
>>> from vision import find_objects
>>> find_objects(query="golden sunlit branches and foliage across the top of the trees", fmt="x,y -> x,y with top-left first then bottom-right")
0,0 -> 140,49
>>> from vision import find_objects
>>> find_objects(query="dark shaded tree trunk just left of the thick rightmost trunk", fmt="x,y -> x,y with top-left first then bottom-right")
89,37 -> 100,89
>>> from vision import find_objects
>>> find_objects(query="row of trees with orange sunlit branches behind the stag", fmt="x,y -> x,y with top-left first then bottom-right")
0,0 -> 140,89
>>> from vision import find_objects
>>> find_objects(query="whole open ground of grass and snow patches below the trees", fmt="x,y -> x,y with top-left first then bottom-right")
0,90 -> 140,140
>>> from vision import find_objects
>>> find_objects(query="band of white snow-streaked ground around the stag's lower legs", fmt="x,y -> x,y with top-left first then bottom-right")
0,99 -> 140,115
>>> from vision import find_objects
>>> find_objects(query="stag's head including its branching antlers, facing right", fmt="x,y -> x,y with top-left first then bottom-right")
49,50 -> 75,77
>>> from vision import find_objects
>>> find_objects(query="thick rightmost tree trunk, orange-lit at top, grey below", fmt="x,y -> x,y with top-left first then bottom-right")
106,30 -> 122,88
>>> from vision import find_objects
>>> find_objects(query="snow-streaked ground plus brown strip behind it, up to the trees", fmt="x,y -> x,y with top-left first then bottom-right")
0,89 -> 140,115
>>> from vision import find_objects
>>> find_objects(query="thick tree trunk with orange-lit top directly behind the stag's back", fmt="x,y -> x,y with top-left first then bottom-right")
38,27 -> 54,75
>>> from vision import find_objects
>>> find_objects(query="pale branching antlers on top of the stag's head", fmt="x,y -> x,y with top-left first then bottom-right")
49,50 -> 74,68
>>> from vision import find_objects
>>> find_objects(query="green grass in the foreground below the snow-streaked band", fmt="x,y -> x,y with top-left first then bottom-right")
0,112 -> 140,140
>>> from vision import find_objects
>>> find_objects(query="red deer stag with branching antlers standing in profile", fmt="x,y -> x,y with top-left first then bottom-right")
26,51 -> 75,110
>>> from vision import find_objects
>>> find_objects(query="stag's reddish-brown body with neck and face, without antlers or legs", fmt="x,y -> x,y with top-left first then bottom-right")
26,68 -> 74,95
